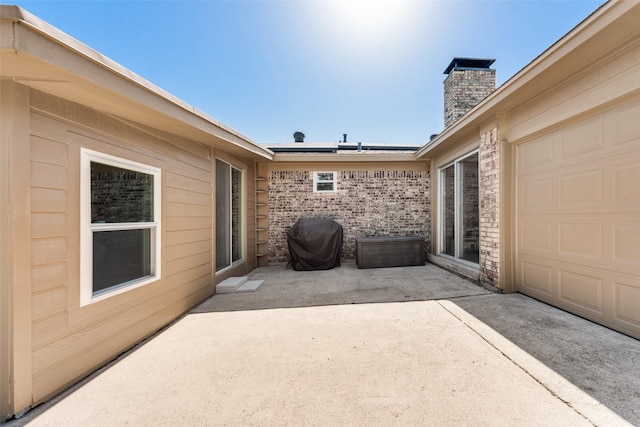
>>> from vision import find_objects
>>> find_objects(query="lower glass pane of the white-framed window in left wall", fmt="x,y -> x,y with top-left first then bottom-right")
93,228 -> 152,294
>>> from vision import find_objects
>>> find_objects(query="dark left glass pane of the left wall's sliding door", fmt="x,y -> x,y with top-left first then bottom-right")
216,160 -> 231,271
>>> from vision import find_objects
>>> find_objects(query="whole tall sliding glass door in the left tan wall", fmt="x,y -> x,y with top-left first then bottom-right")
216,160 -> 242,271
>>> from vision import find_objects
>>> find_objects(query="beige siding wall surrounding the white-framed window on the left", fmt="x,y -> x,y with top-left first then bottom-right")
25,91 -> 220,402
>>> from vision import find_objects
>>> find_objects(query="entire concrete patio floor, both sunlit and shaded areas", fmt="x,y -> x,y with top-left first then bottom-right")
8,264 -> 640,427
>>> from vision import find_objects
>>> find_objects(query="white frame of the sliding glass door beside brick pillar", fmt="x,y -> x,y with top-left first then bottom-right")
438,150 -> 480,268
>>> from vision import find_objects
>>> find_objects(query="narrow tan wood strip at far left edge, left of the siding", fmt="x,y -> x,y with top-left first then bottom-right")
0,79 -> 33,422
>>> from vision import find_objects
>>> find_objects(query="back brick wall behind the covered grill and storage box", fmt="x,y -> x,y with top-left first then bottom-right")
268,168 -> 431,263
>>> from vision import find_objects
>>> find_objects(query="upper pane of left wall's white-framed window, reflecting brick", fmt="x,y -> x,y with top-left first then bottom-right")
91,162 -> 154,224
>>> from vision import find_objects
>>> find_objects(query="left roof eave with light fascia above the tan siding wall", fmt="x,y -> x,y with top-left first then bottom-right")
0,5 -> 274,159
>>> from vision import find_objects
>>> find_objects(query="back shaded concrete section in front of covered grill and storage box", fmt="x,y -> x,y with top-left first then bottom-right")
191,264 -> 492,313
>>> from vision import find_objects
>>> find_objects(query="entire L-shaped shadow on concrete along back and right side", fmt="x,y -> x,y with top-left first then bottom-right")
191,264 -> 640,426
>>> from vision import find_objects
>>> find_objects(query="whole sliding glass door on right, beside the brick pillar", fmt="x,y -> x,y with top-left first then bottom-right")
440,152 -> 480,264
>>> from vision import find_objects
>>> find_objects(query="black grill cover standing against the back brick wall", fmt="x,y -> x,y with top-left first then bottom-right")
287,218 -> 342,271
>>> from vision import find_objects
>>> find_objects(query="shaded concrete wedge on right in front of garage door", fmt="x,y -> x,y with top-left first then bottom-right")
454,293 -> 640,426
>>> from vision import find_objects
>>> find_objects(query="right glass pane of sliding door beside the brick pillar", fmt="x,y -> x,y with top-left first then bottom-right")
460,154 -> 480,264
